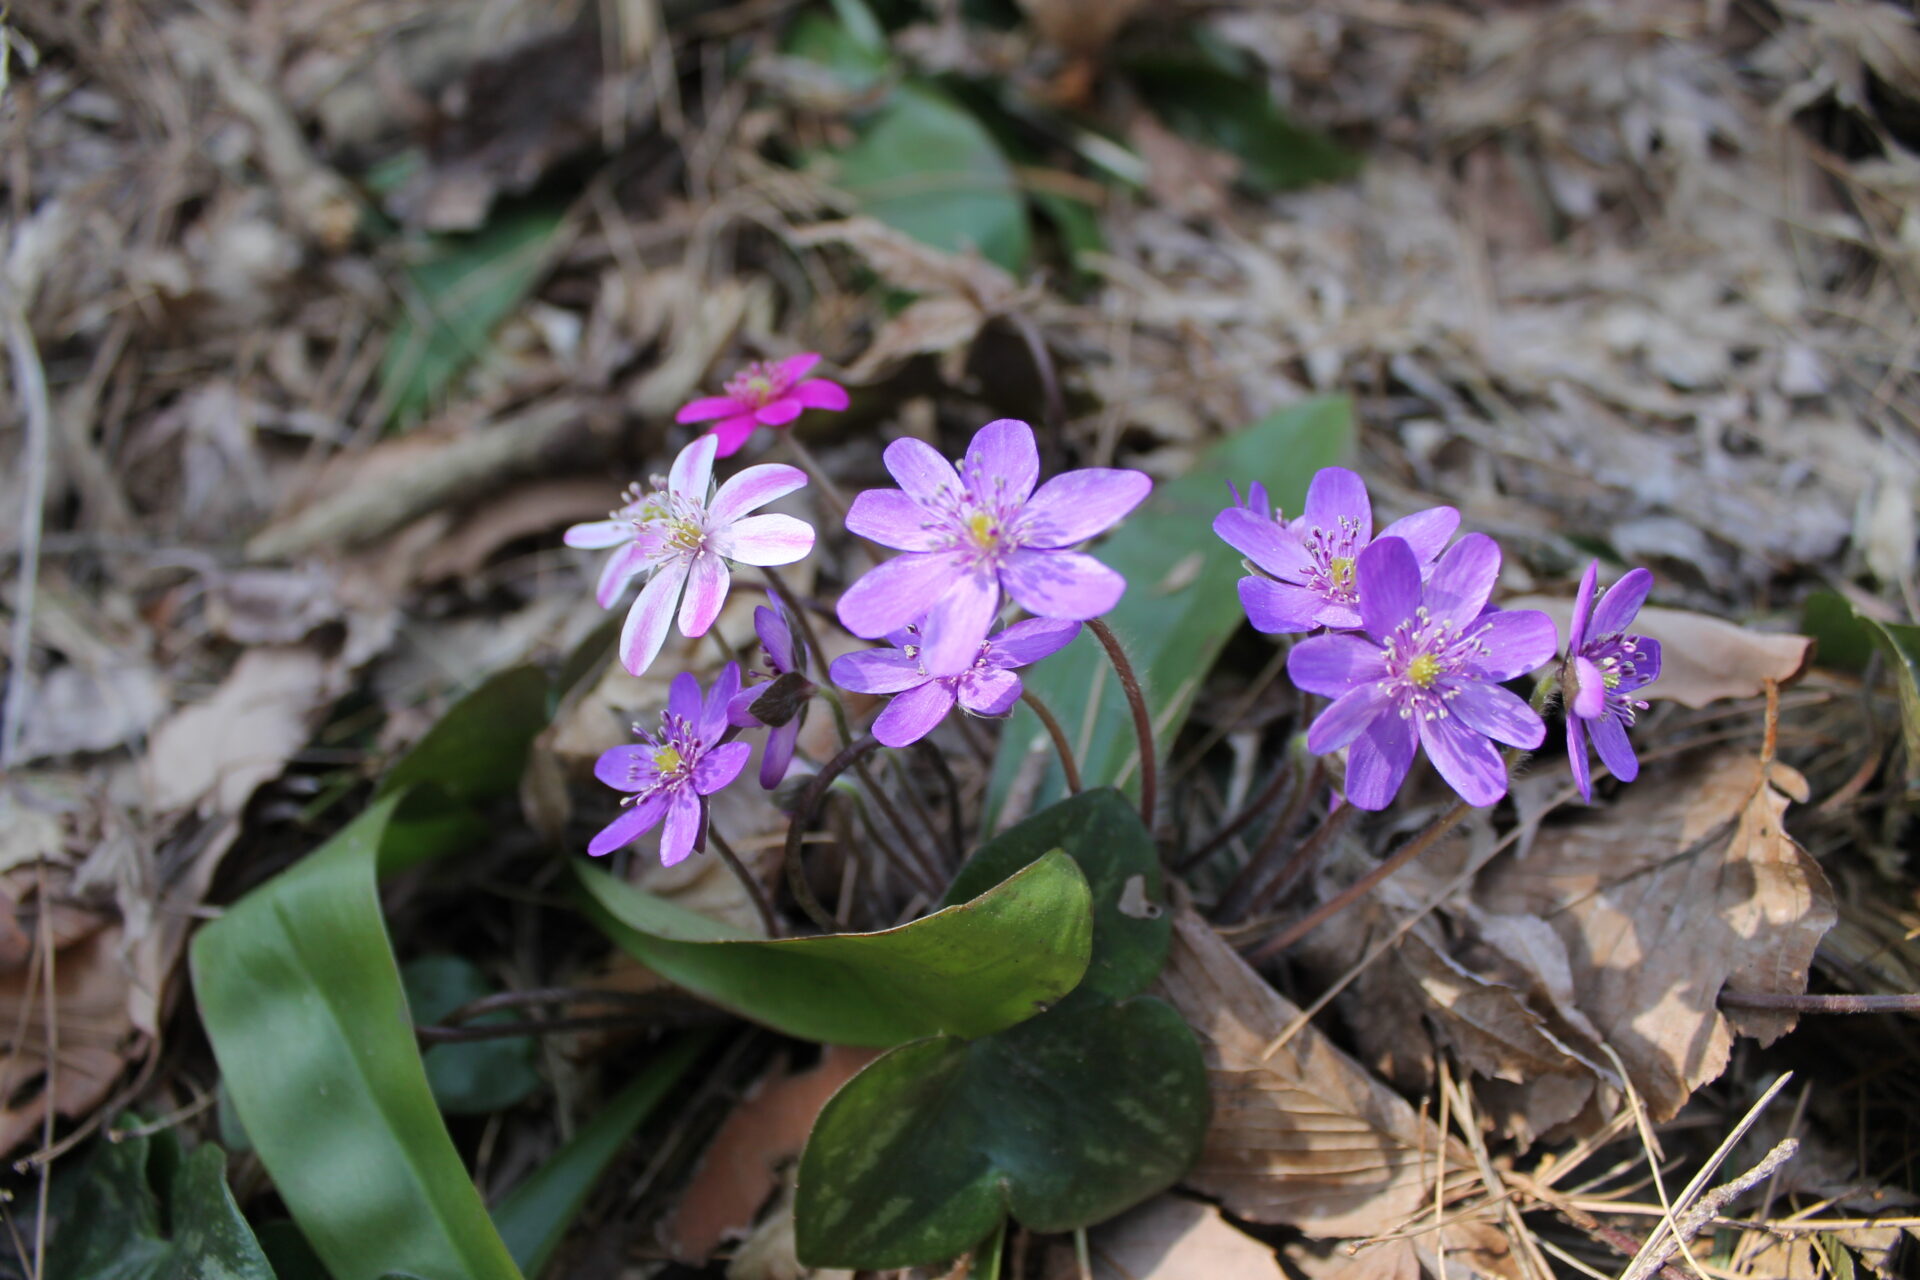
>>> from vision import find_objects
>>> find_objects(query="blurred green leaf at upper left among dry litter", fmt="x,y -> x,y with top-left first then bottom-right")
380,207 -> 564,422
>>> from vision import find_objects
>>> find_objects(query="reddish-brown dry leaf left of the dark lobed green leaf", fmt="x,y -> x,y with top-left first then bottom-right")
668,1046 -> 879,1263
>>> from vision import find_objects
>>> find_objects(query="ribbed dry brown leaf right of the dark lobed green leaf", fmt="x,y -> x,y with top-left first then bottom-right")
1156,906 -> 1469,1236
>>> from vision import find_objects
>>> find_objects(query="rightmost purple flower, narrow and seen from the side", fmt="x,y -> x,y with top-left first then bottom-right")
1561,560 -> 1661,800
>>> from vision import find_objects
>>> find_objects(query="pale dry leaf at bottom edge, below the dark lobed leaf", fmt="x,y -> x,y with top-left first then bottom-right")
1046,1196 -> 1284,1280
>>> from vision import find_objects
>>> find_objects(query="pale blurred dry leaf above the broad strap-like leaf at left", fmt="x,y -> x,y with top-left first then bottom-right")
146,649 -> 338,814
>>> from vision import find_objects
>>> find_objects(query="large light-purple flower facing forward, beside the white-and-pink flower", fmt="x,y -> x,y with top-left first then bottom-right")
839,418 -> 1152,676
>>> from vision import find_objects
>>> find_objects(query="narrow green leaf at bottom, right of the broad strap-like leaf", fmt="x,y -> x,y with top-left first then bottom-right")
493,1031 -> 714,1276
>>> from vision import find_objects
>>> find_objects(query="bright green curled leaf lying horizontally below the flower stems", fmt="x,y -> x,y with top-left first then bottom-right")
576,854 -> 1092,1046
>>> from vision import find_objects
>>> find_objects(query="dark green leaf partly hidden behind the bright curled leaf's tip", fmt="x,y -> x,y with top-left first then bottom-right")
947,787 -> 1173,1007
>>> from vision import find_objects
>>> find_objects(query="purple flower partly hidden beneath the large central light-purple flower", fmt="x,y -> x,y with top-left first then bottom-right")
831,618 -> 1079,747
